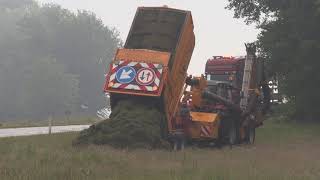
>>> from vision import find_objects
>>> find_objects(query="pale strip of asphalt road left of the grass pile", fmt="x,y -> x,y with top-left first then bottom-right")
0,125 -> 90,137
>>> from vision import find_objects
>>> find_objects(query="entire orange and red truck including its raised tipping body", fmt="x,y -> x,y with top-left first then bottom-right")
104,7 -> 265,149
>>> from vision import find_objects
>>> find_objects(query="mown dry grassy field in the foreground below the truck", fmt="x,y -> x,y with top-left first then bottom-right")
0,119 -> 320,180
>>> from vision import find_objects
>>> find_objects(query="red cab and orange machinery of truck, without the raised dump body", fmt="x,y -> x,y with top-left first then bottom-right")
175,47 -> 270,149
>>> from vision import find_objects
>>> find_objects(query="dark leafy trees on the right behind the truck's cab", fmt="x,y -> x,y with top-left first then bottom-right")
227,0 -> 320,121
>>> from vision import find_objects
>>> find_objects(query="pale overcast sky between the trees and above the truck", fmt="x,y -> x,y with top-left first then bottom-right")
38,0 -> 259,75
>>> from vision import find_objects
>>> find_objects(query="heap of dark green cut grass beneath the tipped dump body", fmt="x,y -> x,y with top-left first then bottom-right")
74,99 -> 168,149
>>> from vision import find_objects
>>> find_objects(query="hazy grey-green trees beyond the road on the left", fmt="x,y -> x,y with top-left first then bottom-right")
0,0 -> 121,119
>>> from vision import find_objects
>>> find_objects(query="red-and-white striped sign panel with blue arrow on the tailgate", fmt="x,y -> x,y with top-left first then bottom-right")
107,61 -> 163,93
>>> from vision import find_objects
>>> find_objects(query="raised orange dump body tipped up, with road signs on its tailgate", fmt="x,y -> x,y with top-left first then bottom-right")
105,7 -> 195,132
